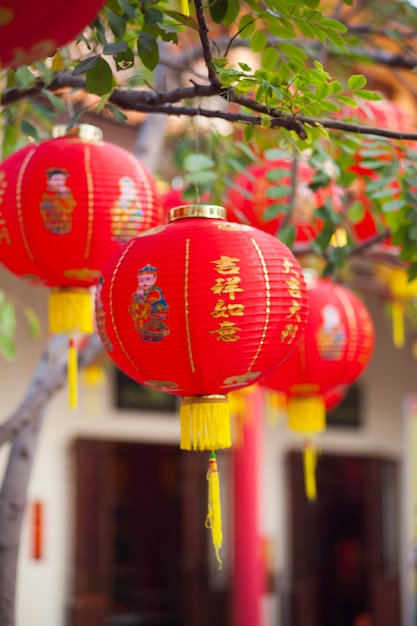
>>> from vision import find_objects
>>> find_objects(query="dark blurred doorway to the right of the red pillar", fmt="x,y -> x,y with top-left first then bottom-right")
286,453 -> 401,626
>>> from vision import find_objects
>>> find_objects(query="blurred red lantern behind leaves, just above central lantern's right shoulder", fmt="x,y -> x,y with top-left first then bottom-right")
225,159 -> 342,242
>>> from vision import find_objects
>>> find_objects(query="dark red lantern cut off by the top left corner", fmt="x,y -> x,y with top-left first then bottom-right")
0,0 -> 104,67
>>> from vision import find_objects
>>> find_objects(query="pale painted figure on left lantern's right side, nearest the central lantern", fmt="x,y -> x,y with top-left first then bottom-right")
111,176 -> 143,241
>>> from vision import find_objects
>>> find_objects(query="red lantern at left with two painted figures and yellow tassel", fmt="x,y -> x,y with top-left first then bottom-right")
0,125 -> 163,406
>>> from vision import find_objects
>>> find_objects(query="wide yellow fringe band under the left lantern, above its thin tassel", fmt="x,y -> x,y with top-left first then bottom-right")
49,289 -> 94,334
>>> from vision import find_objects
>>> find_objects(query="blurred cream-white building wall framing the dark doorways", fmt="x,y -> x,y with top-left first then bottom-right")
0,270 -> 417,626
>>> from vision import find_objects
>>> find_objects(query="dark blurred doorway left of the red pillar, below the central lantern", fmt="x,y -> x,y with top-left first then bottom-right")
69,439 -> 228,626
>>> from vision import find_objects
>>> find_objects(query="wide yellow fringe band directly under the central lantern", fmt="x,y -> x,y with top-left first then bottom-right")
180,395 -> 231,450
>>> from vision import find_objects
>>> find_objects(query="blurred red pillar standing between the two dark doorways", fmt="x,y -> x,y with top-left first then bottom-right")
232,389 -> 265,626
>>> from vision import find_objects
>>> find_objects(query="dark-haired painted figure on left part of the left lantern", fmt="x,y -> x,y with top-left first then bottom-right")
39,168 -> 76,235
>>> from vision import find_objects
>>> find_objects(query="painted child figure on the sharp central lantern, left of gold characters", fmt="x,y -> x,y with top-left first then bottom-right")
129,263 -> 169,342
